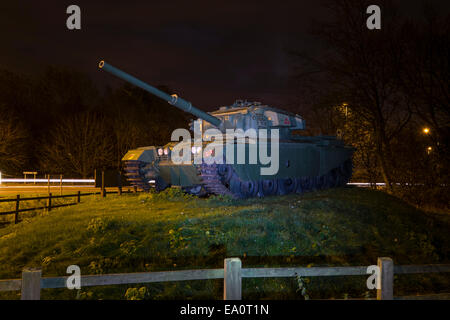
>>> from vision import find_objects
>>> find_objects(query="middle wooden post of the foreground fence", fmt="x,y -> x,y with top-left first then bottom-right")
223,258 -> 242,300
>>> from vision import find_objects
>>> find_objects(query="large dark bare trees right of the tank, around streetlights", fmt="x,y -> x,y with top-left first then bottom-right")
294,0 -> 450,208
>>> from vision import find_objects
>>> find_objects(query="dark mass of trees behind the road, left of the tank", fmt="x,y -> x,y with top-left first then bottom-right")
0,66 -> 191,177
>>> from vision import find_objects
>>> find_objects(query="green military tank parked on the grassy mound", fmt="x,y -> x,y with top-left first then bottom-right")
99,61 -> 354,198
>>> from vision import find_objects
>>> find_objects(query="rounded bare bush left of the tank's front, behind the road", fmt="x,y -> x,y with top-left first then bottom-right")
41,112 -> 114,178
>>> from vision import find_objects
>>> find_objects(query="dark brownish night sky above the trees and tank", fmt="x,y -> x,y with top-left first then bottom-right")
0,0 -> 450,110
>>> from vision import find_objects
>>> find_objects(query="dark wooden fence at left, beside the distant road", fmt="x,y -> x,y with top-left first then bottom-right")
0,187 -> 137,223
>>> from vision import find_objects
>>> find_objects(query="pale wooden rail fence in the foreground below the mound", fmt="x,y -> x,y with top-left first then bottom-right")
0,258 -> 450,300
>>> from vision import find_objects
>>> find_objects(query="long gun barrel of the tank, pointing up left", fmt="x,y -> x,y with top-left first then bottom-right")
98,60 -> 222,127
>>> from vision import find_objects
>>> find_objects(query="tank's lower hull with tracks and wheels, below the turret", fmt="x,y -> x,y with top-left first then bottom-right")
123,137 -> 354,198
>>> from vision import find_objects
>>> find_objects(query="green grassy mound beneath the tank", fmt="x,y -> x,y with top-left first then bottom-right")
0,188 -> 450,299
